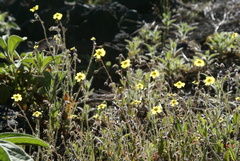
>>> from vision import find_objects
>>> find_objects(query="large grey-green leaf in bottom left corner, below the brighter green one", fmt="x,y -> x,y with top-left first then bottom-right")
0,139 -> 33,161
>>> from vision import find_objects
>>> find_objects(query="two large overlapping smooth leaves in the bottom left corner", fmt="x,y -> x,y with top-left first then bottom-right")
0,133 -> 49,161
